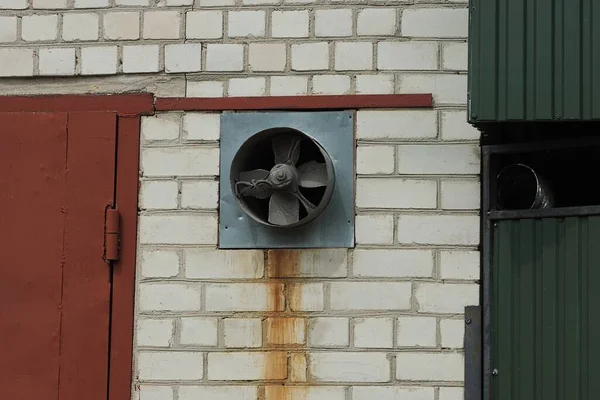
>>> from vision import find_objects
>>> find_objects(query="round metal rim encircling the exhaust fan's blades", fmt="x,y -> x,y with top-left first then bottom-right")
229,126 -> 335,229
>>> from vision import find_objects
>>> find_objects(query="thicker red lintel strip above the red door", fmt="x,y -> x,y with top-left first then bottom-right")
0,93 -> 154,115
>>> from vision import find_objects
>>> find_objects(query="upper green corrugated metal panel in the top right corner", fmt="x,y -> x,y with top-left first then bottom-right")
469,0 -> 600,123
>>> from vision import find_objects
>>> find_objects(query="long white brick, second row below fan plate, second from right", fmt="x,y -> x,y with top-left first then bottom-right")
331,282 -> 411,310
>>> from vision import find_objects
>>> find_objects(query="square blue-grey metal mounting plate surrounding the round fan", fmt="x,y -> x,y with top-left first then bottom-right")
219,111 -> 356,249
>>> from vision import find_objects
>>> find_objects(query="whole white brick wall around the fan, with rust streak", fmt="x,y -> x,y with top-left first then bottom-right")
0,0 -> 479,394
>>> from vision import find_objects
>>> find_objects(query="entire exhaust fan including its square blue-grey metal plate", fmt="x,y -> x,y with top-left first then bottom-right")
219,112 -> 354,248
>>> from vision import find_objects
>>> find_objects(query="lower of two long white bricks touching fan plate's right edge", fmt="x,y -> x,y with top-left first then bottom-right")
356,178 -> 437,209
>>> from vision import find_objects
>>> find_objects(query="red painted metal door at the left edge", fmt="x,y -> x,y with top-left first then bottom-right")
0,112 -> 116,400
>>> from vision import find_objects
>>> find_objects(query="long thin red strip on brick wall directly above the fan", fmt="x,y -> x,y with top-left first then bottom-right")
155,93 -> 433,111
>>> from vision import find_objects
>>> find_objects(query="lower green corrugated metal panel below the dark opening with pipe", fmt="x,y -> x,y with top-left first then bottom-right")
492,217 -> 600,400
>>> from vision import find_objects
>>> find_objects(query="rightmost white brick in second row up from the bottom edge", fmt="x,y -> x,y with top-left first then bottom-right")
396,353 -> 465,381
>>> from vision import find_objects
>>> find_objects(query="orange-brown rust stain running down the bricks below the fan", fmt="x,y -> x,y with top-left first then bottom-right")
263,250 -> 307,400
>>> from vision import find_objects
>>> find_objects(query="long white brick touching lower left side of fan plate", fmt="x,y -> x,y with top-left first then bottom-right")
139,215 -> 217,244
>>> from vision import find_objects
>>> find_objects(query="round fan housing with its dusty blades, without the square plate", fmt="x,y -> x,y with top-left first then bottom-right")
230,127 -> 335,228
